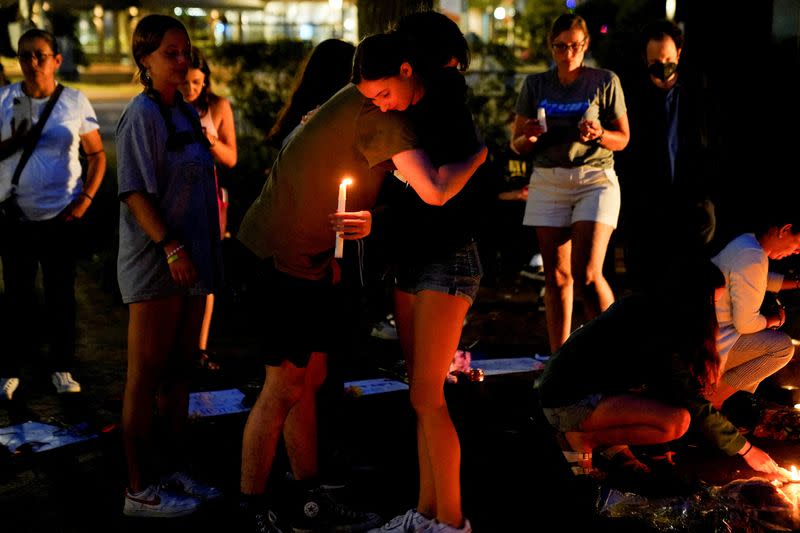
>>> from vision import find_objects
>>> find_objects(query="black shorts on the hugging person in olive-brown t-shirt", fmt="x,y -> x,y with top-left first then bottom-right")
259,259 -> 346,367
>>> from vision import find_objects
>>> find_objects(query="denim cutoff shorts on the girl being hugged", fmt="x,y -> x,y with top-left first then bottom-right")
395,241 -> 483,305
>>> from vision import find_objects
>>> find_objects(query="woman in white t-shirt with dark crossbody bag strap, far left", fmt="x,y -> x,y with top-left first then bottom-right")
0,29 -> 106,400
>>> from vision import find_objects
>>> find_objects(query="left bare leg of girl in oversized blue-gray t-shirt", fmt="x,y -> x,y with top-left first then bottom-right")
122,297 -> 182,492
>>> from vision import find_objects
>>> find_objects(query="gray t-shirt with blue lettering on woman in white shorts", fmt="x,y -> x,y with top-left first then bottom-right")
516,67 -> 627,168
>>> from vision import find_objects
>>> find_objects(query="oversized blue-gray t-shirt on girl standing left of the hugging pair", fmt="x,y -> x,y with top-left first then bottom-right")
117,94 -> 222,303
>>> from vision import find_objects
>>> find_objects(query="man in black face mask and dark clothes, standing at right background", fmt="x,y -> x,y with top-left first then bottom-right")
619,21 -> 715,288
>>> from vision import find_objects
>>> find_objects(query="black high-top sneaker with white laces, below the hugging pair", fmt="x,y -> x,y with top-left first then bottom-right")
292,488 -> 382,533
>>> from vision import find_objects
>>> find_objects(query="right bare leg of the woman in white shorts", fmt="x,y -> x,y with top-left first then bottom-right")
572,221 -> 614,320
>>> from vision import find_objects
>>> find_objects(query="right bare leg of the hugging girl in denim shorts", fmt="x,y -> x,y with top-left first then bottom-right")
411,290 -> 469,527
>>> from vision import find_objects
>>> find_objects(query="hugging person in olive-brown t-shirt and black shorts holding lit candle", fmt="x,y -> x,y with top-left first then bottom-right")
233,33 -> 486,531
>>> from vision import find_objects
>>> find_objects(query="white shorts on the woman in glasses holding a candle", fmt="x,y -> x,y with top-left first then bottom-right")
522,166 -> 620,228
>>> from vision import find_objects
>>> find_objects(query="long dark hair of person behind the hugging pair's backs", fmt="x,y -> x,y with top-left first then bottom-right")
267,39 -> 355,144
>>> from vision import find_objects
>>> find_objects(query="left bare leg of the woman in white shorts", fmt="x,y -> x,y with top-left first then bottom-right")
536,227 -> 573,352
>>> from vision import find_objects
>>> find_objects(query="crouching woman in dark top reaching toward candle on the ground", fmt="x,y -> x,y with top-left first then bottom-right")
539,262 -> 779,474
